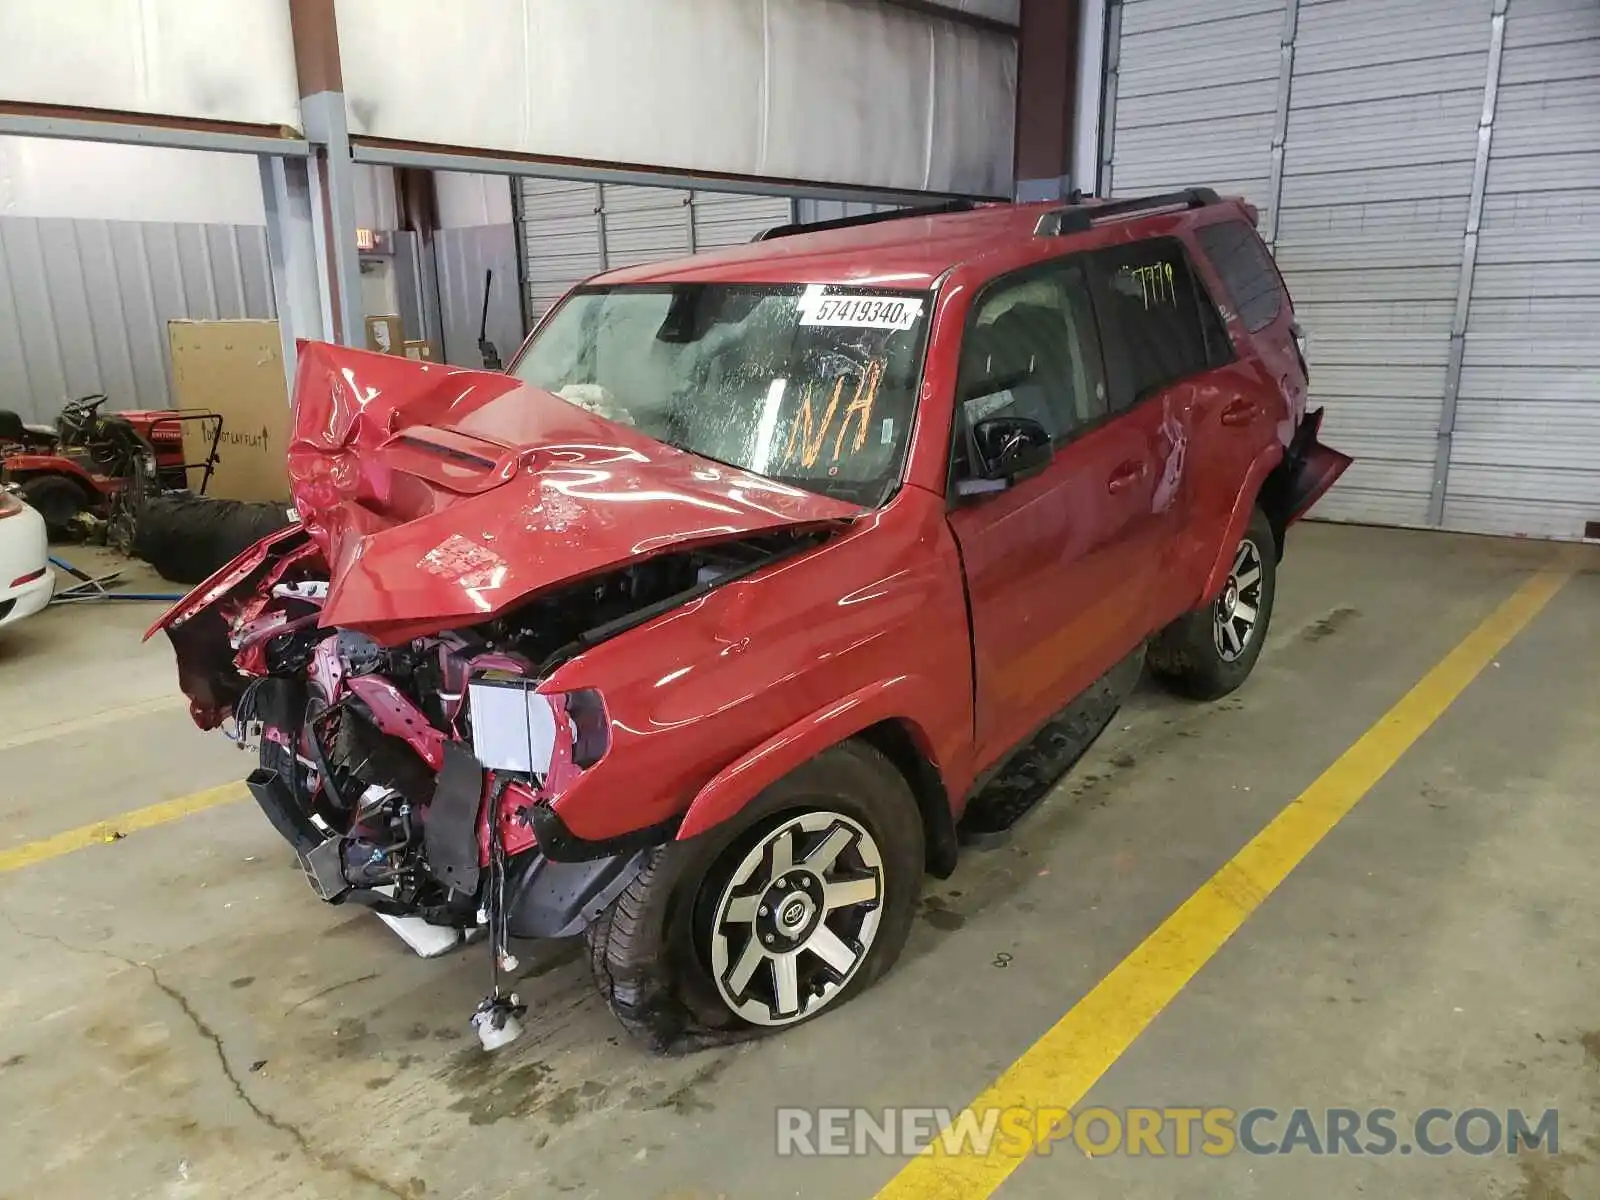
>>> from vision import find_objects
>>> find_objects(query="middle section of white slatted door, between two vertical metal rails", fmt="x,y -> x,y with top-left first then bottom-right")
1277,0 -> 1491,525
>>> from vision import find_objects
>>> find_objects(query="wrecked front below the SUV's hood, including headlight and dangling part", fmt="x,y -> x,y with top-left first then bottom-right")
152,526 -> 825,1048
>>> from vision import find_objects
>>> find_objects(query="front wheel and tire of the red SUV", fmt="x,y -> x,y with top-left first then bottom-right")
589,742 -> 923,1053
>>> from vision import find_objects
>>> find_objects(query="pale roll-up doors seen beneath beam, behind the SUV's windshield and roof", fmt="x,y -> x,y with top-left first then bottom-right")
517,179 -> 792,322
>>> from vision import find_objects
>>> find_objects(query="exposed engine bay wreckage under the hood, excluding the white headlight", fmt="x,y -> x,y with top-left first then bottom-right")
200,530 -> 827,930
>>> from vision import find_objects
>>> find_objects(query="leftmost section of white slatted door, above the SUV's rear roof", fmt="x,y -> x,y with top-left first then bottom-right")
1099,0 -> 1283,205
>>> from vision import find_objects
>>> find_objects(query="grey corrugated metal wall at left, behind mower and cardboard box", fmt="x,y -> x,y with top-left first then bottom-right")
0,216 -> 277,421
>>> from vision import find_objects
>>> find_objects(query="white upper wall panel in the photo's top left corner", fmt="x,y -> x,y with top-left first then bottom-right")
0,0 -> 299,128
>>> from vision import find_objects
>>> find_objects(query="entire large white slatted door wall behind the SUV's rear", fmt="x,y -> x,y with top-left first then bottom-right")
1101,0 -> 1600,536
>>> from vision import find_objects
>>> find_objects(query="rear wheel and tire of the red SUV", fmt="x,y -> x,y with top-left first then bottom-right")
1147,509 -> 1278,699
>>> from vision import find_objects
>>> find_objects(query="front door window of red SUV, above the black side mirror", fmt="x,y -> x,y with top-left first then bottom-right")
957,262 -> 1107,457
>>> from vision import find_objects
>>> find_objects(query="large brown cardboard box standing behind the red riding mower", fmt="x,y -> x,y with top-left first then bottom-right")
166,320 -> 290,501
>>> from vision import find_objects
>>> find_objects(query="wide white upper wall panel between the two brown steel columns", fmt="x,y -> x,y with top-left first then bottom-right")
336,0 -> 1016,195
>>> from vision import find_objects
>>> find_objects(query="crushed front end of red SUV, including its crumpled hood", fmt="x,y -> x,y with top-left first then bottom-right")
147,346 -> 854,1048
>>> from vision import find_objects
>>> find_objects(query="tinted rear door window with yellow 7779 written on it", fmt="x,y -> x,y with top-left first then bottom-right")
1088,237 -> 1230,408
